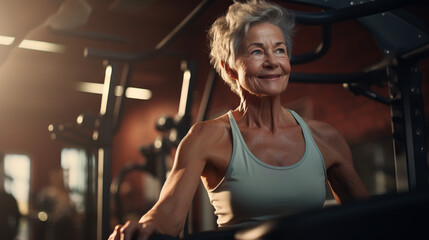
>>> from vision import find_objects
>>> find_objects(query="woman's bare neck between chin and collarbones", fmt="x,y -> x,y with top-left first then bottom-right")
237,94 -> 287,130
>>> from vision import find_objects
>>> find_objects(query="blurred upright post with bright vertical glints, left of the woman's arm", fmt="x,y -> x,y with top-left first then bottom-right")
97,62 -> 120,240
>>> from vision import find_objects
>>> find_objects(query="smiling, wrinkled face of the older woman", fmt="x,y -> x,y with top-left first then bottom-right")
235,23 -> 291,96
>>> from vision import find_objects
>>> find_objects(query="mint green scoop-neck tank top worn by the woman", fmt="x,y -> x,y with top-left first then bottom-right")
208,110 -> 326,229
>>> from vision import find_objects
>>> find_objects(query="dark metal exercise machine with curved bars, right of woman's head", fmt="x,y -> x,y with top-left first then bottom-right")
284,0 -> 429,191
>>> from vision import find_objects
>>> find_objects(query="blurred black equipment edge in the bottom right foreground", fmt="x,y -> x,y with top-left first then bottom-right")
235,192 -> 429,240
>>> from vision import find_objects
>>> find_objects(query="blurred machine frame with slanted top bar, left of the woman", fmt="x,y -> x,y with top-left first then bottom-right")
50,0 -> 214,240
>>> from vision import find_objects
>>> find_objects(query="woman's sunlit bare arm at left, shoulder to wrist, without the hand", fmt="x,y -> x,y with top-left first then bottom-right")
135,125 -> 206,236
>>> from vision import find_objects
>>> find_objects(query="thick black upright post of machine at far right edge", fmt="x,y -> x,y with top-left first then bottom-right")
389,61 -> 429,191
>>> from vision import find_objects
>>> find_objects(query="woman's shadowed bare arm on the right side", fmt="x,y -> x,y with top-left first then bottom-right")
308,121 -> 369,203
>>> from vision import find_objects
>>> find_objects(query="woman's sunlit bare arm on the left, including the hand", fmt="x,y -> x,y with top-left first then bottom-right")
109,124 -> 210,240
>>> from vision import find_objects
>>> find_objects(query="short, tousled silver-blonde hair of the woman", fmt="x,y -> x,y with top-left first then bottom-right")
208,0 -> 295,96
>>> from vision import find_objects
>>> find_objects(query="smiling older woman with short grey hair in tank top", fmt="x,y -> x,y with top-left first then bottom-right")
110,0 -> 368,239
